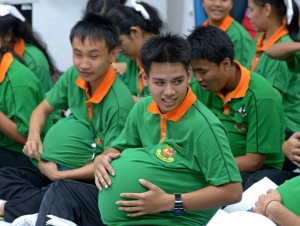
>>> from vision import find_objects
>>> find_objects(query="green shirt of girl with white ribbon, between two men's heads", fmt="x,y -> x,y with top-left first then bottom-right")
117,53 -> 150,97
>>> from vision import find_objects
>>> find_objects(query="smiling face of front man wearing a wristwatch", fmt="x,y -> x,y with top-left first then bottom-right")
144,62 -> 192,114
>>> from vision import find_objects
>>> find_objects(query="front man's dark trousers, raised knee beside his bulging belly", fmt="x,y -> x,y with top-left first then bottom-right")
36,180 -> 104,226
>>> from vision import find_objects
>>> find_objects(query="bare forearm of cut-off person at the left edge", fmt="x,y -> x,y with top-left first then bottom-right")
0,111 -> 27,145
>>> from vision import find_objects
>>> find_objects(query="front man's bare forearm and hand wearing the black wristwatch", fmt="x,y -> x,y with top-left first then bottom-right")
117,179 -> 242,217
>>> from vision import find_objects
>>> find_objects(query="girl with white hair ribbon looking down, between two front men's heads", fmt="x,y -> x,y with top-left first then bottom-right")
107,1 -> 163,102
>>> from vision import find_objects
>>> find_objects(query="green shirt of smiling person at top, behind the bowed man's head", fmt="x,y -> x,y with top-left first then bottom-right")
226,21 -> 255,65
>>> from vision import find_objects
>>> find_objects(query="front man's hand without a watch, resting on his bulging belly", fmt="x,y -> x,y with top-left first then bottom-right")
94,149 -> 120,190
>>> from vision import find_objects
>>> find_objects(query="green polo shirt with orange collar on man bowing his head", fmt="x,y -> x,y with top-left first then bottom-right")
192,64 -> 284,169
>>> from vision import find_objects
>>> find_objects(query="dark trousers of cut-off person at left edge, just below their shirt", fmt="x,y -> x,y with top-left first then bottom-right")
0,147 -> 35,168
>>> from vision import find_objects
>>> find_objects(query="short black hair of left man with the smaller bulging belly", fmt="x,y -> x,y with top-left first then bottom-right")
70,13 -> 119,51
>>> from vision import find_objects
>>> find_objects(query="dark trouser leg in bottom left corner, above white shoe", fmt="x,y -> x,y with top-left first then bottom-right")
0,167 -> 52,222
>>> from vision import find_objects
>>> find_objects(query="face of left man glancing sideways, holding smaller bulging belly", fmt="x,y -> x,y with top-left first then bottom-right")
72,37 -> 114,86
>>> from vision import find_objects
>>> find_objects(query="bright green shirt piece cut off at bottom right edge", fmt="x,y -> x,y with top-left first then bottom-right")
276,176 -> 300,217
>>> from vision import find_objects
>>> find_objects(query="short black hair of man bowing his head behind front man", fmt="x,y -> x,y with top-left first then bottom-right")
187,25 -> 234,65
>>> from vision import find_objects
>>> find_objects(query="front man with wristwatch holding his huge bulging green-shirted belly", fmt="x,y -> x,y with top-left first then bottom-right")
94,34 -> 242,225
